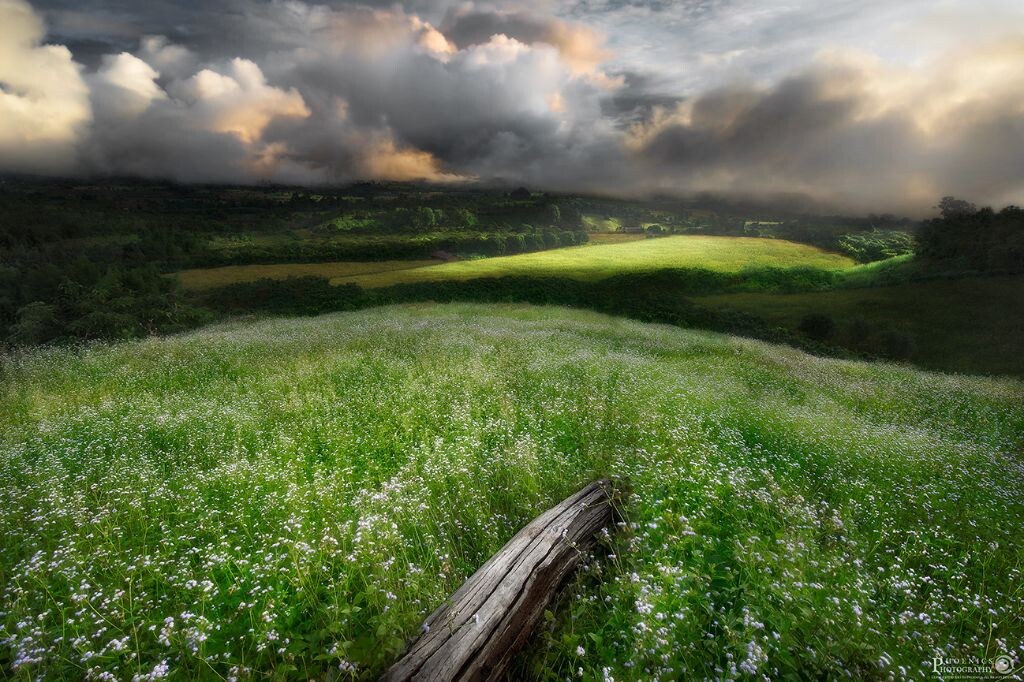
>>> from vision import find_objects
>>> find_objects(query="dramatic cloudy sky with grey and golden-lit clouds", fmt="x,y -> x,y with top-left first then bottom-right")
0,0 -> 1024,215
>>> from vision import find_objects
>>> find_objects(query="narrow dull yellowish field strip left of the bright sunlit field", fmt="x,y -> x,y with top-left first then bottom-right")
177,260 -> 439,291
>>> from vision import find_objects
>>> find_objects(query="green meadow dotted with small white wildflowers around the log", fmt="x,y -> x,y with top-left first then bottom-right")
0,305 -> 1024,680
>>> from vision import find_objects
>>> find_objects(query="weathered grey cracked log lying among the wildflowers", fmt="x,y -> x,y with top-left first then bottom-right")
381,480 -> 614,682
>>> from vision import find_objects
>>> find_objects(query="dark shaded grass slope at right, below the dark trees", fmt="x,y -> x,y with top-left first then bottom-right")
694,275 -> 1024,375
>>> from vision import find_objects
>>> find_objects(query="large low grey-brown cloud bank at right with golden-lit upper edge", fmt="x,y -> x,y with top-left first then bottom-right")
634,52 -> 1024,211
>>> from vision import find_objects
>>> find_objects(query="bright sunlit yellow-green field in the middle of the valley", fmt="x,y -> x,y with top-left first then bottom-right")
332,236 -> 854,287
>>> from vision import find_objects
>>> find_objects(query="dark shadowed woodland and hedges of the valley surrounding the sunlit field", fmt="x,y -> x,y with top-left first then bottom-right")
0,179 -> 1024,356
